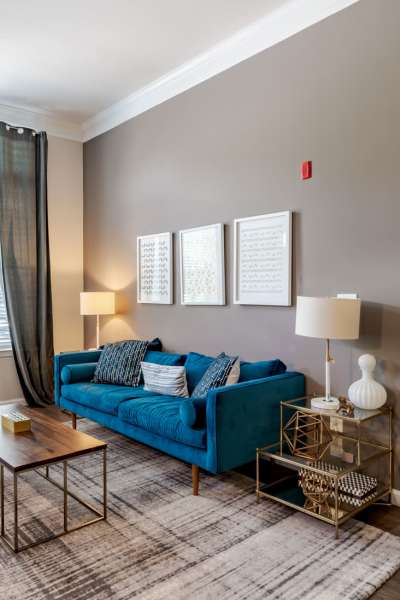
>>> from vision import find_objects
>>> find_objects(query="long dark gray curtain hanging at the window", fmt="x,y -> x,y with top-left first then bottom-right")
0,122 -> 53,406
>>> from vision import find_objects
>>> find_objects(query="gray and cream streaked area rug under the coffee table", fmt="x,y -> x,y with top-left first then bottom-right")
0,421 -> 400,600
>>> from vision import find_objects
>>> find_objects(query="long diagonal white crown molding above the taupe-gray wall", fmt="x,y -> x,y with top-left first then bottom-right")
82,0 -> 360,142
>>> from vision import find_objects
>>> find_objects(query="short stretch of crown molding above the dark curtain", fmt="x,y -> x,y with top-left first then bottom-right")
0,104 -> 82,142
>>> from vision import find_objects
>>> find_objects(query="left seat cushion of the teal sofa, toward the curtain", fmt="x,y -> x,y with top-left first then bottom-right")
61,383 -> 154,415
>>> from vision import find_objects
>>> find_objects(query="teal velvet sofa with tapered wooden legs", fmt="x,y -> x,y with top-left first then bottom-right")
54,350 -> 305,495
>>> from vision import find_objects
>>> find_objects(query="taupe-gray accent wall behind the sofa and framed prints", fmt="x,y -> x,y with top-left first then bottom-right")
84,0 -> 400,488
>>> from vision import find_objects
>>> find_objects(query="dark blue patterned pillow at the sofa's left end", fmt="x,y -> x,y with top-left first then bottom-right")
93,340 -> 149,387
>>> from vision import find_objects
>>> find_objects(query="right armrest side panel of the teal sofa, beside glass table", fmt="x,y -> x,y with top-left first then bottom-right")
207,372 -> 305,473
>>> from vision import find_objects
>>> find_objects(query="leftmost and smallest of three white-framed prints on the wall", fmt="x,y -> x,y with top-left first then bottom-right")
136,232 -> 173,304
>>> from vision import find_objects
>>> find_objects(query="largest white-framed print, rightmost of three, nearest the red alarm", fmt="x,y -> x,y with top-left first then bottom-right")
233,210 -> 292,306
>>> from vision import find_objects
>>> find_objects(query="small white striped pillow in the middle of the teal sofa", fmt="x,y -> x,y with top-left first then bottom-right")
142,362 -> 189,398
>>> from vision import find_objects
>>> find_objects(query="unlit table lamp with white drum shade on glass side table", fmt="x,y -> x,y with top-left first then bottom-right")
296,296 -> 361,409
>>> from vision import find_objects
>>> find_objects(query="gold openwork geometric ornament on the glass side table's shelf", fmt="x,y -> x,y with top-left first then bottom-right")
282,410 -> 332,460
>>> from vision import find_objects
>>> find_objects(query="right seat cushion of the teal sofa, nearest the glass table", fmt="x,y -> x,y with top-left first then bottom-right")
118,395 -> 207,448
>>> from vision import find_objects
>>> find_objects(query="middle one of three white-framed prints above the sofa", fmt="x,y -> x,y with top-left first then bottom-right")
179,223 -> 225,306
